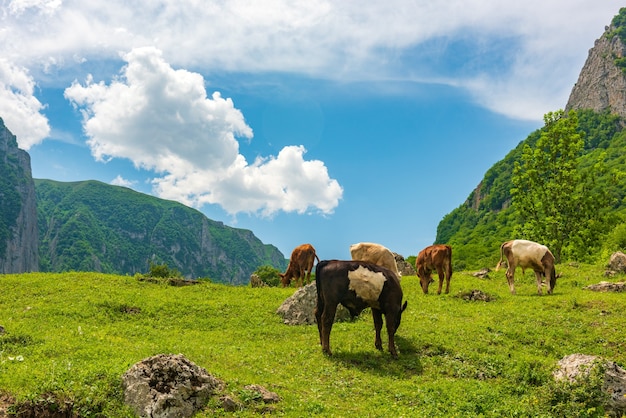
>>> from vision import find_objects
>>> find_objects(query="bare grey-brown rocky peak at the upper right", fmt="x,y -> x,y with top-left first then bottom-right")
565,25 -> 626,117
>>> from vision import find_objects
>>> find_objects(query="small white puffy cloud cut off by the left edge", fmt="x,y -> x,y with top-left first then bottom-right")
0,58 -> 50,150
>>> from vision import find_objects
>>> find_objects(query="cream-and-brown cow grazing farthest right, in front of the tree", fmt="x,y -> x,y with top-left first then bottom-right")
496,239 -> 556,295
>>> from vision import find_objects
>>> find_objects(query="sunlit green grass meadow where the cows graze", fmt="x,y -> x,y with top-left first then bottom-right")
0,265 -> 626,417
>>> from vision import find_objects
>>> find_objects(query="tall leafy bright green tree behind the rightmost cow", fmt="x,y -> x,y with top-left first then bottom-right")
511,110 -> 609,262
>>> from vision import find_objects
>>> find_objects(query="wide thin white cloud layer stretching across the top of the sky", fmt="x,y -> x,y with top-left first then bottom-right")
0,0 -> 619,120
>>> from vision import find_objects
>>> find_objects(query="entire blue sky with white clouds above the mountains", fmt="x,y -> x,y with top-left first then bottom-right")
0,0 -> 620,259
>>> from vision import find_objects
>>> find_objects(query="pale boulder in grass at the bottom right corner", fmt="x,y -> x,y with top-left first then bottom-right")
553,354 -> 626,416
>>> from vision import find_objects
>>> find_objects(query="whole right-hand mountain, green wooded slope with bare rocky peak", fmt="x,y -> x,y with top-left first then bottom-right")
435,8 -> 626,269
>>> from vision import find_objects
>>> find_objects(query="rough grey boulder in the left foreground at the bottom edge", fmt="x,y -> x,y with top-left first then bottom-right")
122,354 -> 224,418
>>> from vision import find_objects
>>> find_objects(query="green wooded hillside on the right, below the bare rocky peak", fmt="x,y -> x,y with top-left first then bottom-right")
436,110 -> 626,269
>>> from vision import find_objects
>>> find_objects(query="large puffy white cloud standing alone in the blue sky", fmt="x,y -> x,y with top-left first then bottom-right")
65,47 -> 343,216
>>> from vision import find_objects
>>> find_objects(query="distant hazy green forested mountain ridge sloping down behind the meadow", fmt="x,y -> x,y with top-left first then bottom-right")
35,179 -> 287,284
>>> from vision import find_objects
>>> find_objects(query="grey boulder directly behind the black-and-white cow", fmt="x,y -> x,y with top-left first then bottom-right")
276,282 -> 351,325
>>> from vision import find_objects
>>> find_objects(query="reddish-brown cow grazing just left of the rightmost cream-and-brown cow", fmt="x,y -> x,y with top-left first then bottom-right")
415,244 -> 452,295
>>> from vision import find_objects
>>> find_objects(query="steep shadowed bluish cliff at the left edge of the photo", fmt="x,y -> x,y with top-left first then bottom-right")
0,118 -> 39,274
